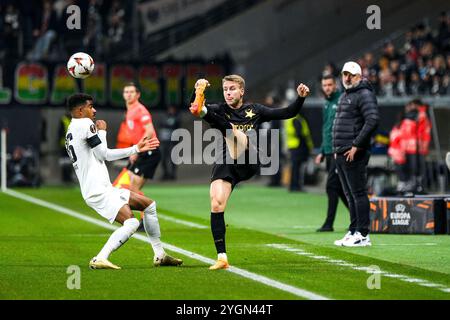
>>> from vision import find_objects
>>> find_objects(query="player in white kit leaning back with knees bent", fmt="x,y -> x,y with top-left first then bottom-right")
66,93 -> 183,269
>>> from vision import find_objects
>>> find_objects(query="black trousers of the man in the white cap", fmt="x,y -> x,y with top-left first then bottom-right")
336,150 -> 370,236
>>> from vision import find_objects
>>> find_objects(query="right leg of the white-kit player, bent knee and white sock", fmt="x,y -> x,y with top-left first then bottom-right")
128,191 -> 183,267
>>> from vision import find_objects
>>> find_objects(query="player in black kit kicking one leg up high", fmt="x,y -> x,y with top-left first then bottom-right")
190,75 -> 309,270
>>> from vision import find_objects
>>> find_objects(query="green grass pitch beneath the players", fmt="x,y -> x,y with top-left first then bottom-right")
0,184 -> 450,300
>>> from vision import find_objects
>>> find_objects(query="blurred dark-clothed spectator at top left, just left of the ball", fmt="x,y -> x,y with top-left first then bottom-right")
27,0 -> 58,61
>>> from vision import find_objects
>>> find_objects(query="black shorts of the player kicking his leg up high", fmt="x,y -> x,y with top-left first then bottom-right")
211,164 -> 259,188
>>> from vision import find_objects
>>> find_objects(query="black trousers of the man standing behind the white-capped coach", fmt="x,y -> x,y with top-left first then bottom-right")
323,154 -> 348,228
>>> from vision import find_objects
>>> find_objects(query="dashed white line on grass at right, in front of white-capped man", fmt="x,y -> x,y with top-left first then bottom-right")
266,243 -> 450,293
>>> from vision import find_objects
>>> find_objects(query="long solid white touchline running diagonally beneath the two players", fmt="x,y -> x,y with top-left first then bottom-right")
4,189 -> 329,300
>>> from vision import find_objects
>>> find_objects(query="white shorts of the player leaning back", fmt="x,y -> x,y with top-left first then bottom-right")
86,186 -> 130,223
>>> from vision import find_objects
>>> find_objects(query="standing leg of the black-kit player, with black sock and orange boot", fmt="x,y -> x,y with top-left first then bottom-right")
209,179 -> 232,270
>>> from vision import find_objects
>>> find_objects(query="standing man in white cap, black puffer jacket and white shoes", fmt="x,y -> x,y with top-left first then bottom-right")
333,61 -> 379,247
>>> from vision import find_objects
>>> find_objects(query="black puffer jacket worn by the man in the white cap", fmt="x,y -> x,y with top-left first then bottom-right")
333,80 -> 379,154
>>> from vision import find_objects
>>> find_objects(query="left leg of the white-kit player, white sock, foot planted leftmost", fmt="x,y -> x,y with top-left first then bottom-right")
89,204 -> 139,269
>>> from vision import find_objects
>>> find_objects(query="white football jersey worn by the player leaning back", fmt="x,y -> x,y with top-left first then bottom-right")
66,118 -> 111,200
